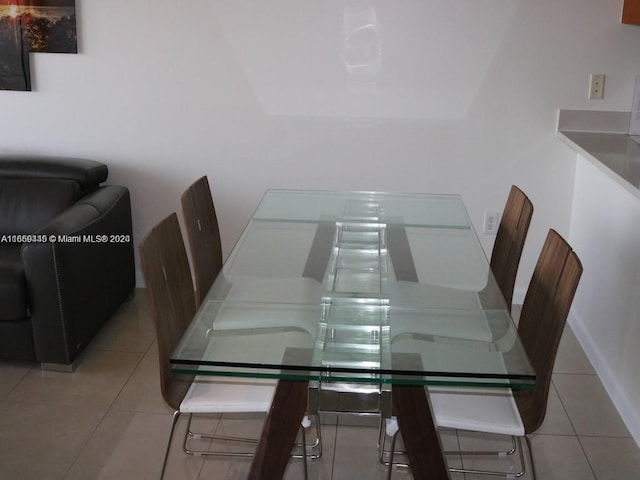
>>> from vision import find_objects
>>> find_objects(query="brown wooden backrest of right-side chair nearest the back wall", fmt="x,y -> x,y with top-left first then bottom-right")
491,185 -> 533,309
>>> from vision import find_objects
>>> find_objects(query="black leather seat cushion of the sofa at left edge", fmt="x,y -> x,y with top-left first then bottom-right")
0,244 -> 27,322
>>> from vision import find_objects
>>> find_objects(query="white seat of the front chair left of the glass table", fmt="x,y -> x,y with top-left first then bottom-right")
180,375 -> 277,413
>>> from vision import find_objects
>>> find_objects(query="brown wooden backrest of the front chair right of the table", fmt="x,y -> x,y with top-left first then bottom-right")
514,230 -> 582,433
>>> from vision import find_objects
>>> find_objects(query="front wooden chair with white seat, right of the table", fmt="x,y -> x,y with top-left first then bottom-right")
383,230 -> 582,478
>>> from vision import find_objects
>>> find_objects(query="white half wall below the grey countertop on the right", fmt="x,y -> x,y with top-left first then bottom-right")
568,155 -> 640,445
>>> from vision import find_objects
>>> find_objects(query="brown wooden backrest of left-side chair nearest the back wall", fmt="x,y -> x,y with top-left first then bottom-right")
182,177 -> 222,305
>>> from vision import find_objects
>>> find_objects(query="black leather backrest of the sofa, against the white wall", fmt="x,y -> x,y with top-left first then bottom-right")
0,156 -> 108,235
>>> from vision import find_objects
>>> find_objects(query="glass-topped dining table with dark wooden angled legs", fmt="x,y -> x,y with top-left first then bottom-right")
171,190 -> 535,479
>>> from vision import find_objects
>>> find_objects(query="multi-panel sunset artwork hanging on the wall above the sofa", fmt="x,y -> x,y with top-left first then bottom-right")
0,0 -> 78,90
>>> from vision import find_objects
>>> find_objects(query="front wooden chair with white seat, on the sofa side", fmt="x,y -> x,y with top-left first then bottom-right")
140,213 -> 306,478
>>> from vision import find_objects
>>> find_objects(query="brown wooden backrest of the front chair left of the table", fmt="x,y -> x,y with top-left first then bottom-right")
140,213 -> 195,410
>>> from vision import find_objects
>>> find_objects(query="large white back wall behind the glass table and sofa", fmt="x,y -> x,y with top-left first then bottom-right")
0,0 -> 640,293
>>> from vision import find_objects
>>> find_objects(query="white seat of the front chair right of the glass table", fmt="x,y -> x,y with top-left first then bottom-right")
429,387 -> 524,437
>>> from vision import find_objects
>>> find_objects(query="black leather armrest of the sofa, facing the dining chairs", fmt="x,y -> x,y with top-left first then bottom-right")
22,186 -> 135,365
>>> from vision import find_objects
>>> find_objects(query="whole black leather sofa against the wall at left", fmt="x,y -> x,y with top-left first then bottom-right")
0,156 -> 135,370
